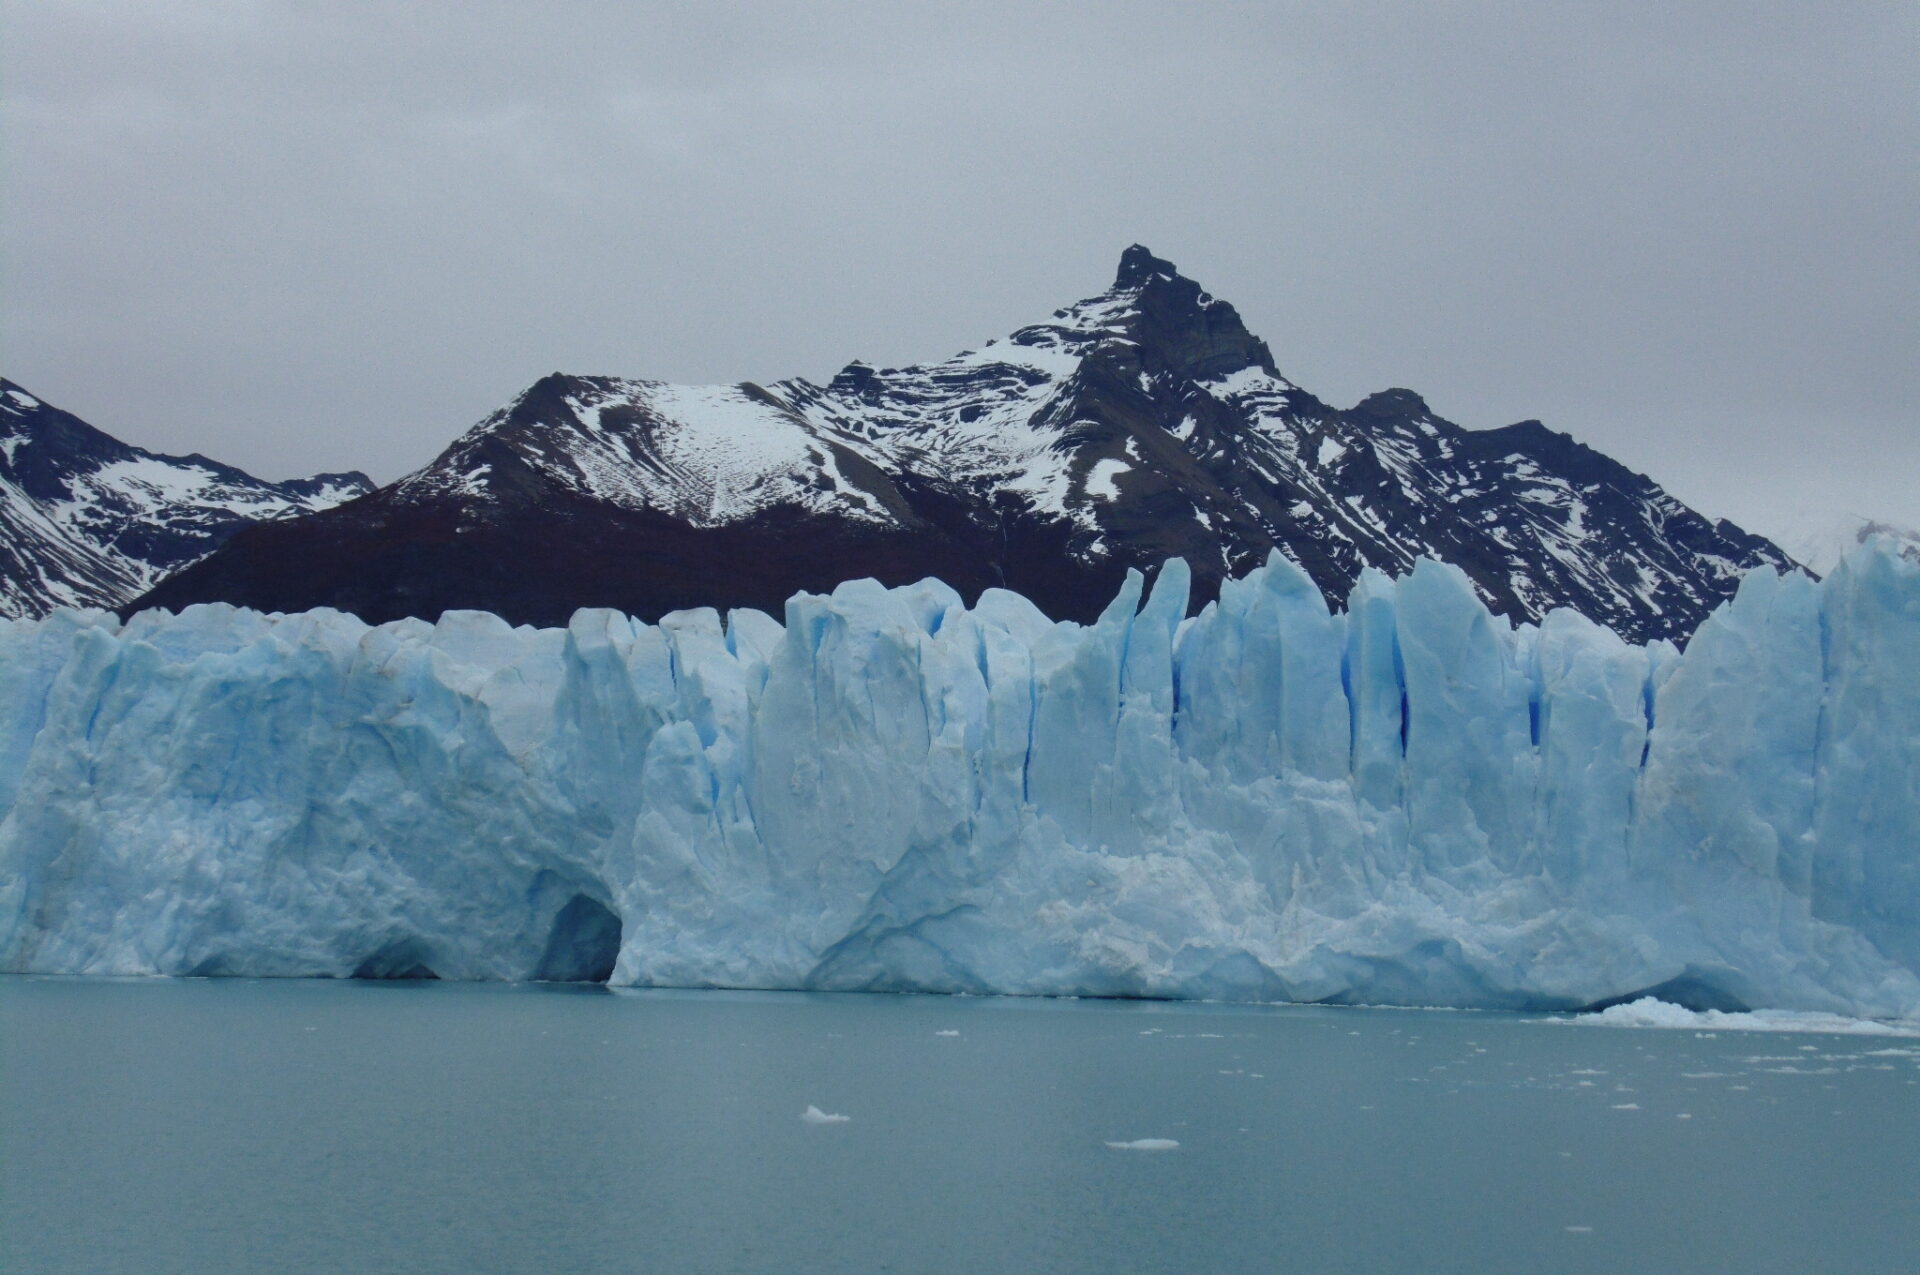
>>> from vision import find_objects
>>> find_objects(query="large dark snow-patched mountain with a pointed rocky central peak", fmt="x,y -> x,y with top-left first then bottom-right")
140,246 -> 1791,639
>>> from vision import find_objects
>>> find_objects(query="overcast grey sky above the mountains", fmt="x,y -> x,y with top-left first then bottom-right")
0,0 -> 1920,547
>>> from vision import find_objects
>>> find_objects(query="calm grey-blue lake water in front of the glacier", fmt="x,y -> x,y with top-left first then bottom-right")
0,977 -> 1920,1273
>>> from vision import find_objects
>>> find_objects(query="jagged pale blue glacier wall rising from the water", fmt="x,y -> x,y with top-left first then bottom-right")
0,541 -> 1920,1018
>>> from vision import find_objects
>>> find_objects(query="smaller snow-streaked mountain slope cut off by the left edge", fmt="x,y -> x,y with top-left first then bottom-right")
0,378 -> 372,618
